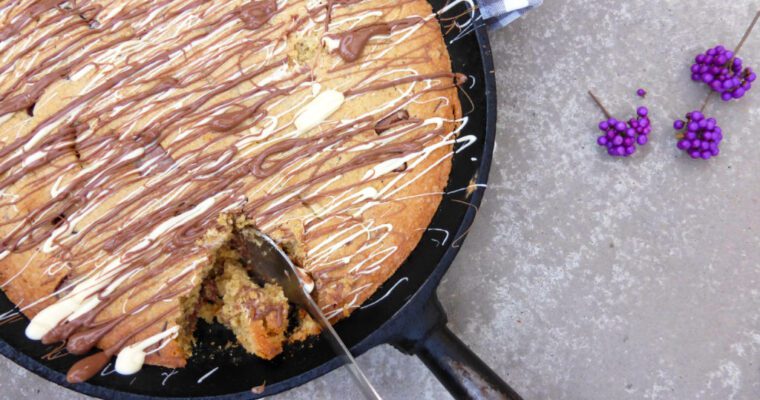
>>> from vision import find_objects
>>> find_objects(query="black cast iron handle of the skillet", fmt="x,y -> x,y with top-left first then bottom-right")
394,295 -> 522,400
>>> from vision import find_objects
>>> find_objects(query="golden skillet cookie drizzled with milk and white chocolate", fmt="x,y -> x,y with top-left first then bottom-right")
0,0 -> 462,373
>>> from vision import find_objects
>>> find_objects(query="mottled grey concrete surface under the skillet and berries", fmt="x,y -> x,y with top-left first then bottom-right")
0,0 -> 760,400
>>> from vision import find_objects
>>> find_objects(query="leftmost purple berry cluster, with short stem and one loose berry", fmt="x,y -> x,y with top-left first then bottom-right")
596,107 -> 652,157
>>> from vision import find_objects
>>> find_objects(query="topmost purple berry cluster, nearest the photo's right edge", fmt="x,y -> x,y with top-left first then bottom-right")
691,45 -> 757,101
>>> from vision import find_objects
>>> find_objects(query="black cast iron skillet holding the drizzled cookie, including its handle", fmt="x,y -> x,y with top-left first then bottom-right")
0,0 -> 519,400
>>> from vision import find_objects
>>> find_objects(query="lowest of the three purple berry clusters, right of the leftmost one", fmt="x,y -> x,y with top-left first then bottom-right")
673,111 -> 723,160
